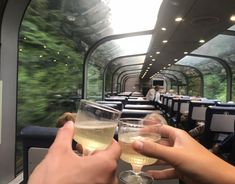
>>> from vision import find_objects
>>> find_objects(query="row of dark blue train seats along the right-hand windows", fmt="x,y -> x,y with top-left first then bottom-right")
160,95 -> 235,165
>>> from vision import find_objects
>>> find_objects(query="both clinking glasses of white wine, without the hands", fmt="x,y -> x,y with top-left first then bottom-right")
74,100 -> 161,184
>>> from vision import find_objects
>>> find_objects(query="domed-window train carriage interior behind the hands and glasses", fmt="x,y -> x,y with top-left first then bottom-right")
0,0 -> 235,184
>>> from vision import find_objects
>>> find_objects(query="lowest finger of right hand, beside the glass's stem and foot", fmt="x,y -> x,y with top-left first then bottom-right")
147,168 -> 178,180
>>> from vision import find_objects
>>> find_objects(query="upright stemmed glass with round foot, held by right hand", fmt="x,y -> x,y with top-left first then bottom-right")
118,118 -> 162,184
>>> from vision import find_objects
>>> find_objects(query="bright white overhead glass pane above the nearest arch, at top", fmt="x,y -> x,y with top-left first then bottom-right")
108,0 -> 162,34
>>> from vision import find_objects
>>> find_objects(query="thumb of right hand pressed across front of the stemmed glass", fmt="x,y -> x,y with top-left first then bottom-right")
132,140 -> 176,164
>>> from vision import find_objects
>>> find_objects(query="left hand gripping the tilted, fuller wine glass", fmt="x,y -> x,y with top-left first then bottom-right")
29,121 -> 121,184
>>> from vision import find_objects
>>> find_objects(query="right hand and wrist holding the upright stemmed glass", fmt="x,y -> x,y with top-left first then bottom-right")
133,125 -> 235,184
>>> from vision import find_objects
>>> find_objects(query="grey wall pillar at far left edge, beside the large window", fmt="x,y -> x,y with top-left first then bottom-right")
0,0 -> 29,183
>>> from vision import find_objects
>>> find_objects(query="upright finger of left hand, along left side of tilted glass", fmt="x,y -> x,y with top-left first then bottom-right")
53,121 -> 74,149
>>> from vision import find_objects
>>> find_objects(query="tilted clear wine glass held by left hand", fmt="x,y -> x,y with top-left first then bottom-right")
74,100 -> 121,155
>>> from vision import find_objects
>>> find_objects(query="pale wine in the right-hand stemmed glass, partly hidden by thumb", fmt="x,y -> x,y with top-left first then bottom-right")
118,132 -> 161,166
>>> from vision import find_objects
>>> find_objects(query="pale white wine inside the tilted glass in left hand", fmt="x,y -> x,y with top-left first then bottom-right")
74,120 -> 117,151
